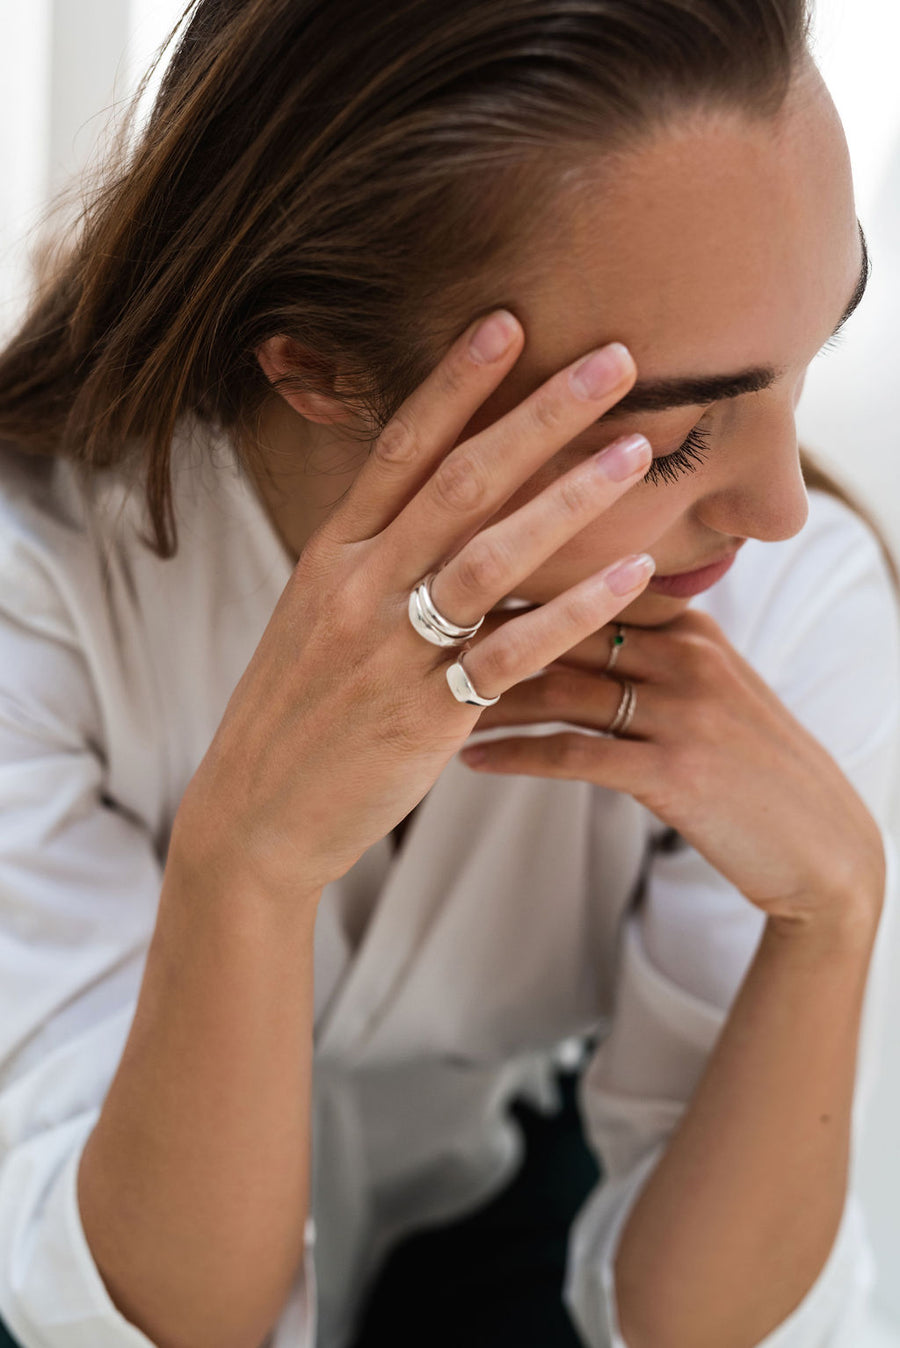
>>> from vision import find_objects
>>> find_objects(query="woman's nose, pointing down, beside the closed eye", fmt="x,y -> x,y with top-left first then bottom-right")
697,399 -> 810,543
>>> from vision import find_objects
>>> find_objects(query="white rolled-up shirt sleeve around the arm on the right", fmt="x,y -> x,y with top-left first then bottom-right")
563,506 -> 900,1348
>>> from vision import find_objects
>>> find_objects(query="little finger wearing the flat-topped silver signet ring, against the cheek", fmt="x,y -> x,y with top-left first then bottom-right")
441,554 -> 655,697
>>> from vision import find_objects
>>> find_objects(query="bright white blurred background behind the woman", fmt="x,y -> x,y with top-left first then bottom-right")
0,0 -> 900,1348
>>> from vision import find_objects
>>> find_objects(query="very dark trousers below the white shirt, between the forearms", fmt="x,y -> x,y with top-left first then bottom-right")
0,1072 -> 601,1348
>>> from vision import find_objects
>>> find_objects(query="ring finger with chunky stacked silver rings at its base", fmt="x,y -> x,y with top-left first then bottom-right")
431,435 -> 652,625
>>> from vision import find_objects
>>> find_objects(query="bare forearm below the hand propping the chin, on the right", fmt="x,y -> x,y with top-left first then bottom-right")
616,895 -> 881,1348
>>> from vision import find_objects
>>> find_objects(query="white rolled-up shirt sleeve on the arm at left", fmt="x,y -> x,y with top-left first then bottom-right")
0,509 -> 314,1348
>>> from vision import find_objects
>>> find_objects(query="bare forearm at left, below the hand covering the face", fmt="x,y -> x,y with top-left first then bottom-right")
78,830 -> 318,1348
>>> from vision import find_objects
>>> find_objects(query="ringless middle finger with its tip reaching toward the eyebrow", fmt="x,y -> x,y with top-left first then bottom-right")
383,342 -> 636,582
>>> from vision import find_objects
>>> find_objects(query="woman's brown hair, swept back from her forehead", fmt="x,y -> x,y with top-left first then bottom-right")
0,0 -> 900,586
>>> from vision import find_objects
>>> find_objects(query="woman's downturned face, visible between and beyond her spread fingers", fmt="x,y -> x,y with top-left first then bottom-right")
461,60 -> 864,627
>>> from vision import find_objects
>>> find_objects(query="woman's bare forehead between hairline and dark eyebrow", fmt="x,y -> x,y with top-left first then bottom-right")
506,67 -> 860,379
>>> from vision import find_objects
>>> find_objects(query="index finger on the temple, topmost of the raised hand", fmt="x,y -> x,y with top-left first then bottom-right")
327,309 -> 524,543
